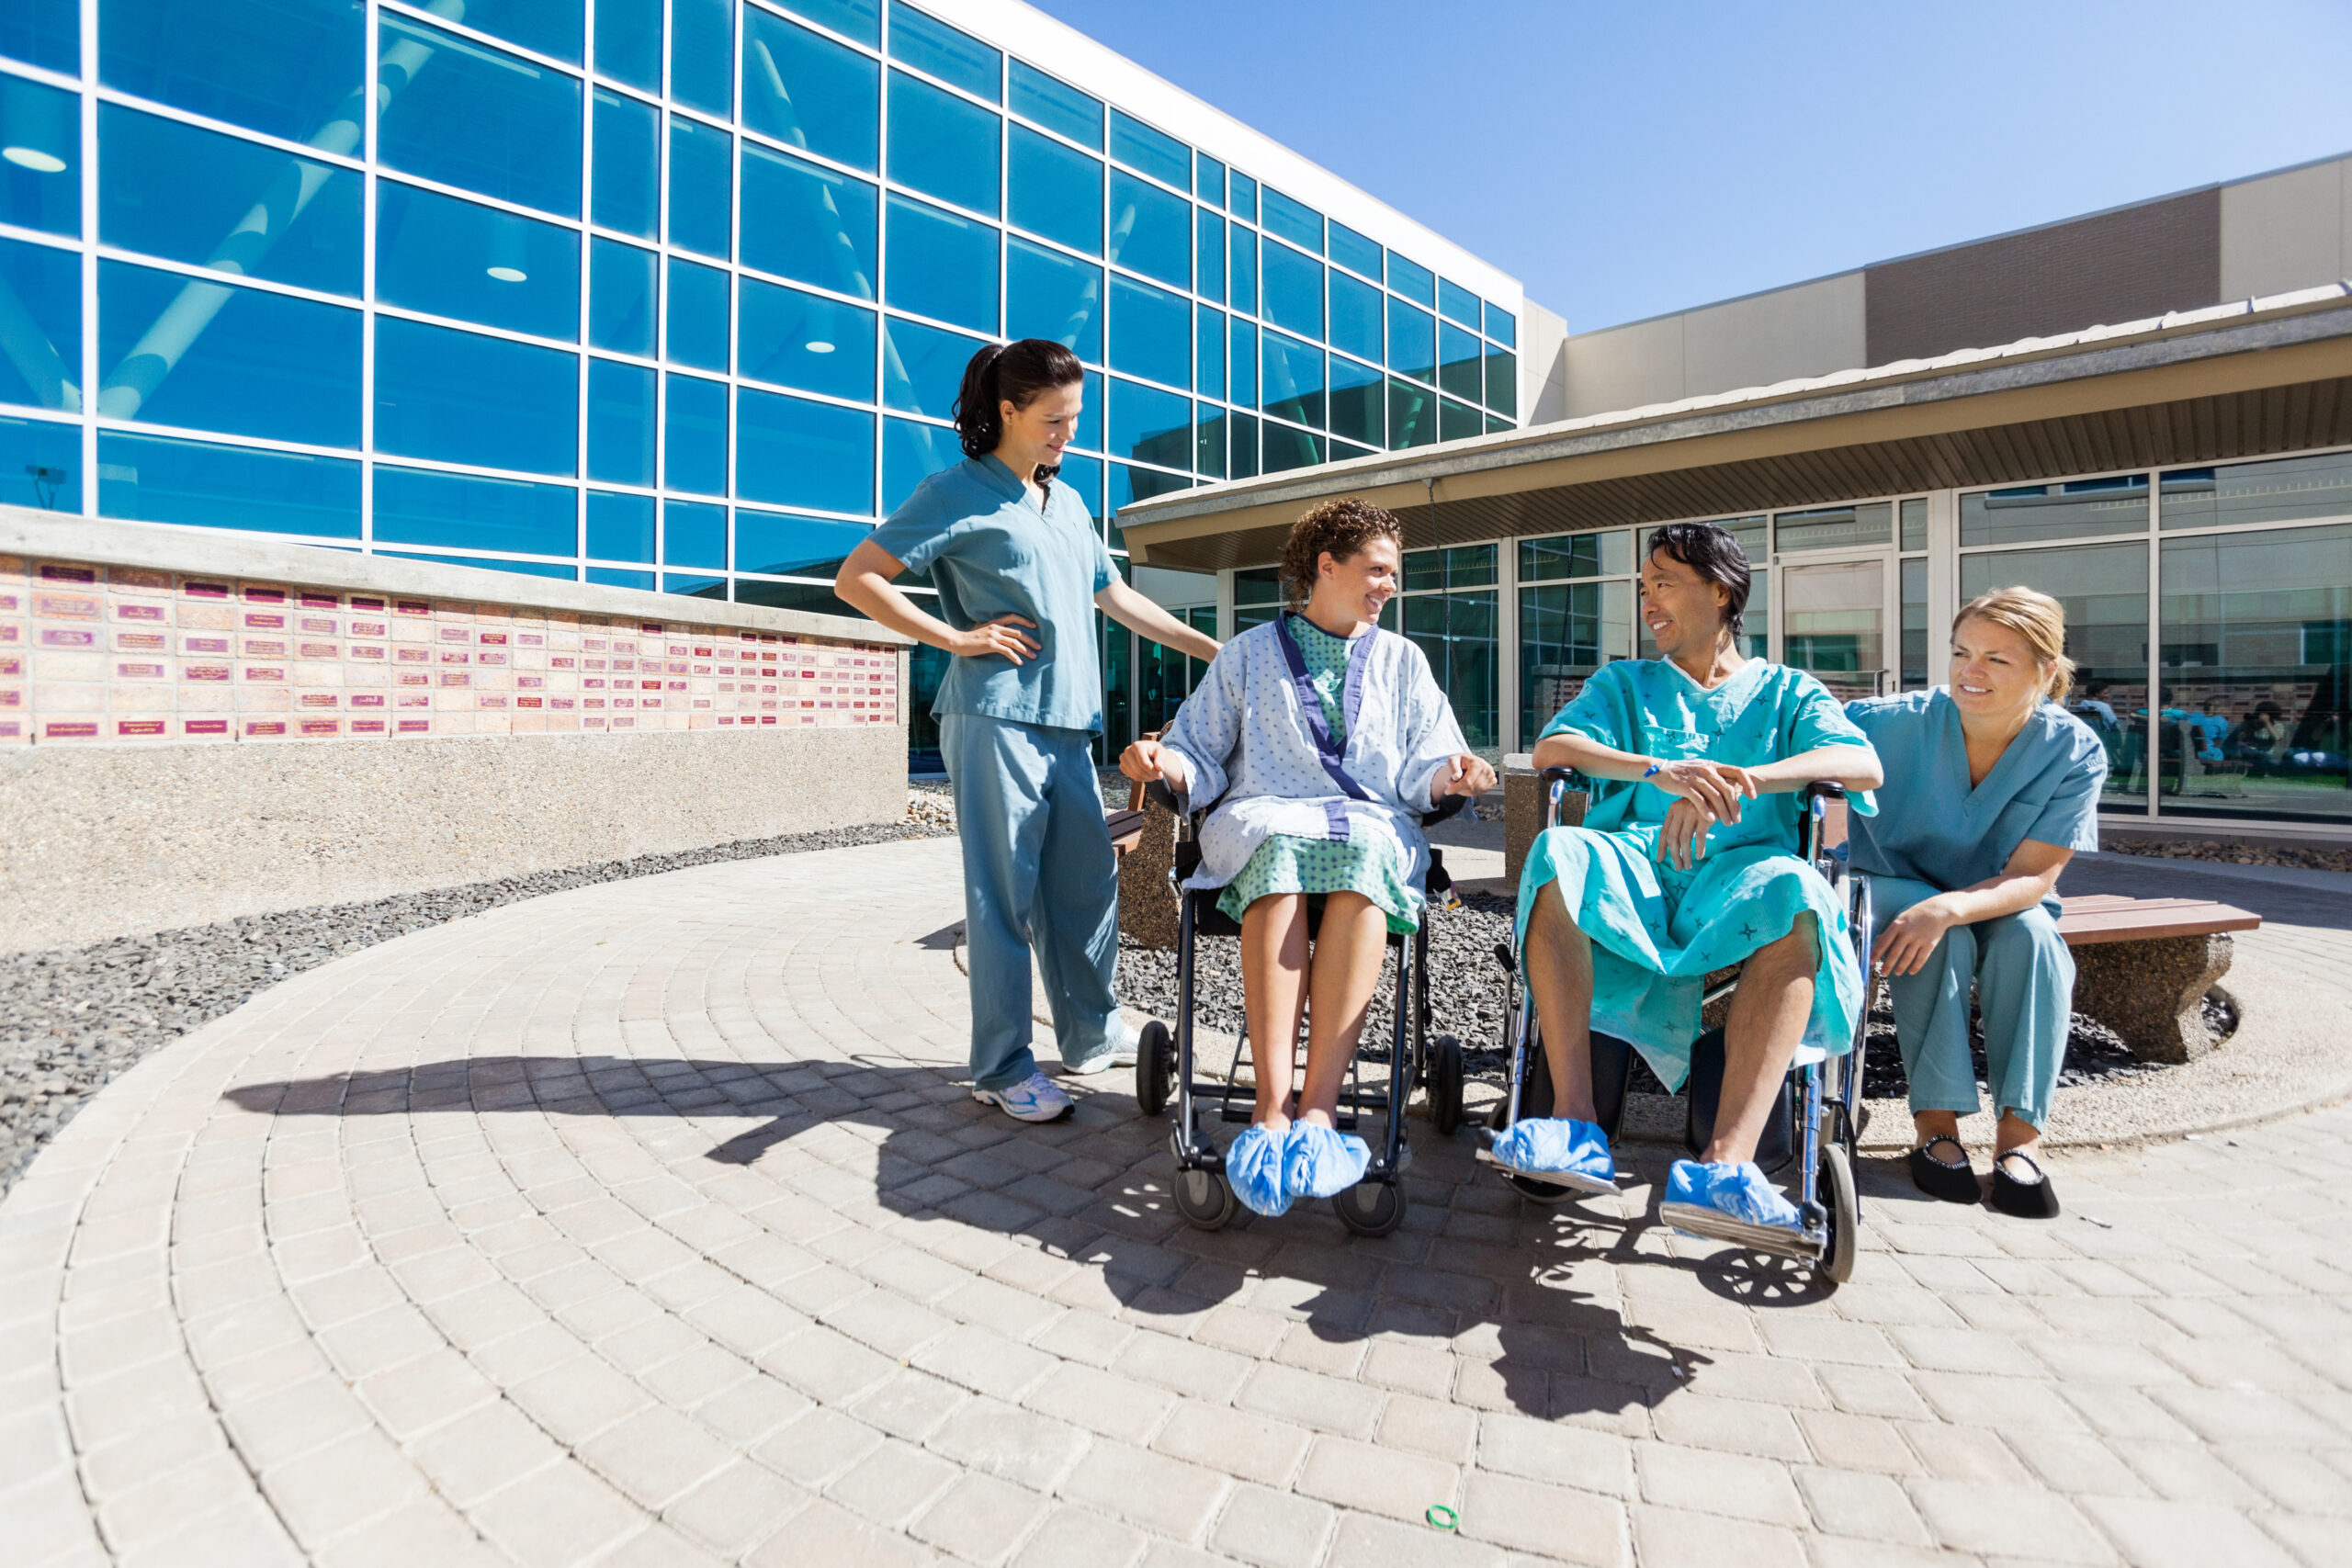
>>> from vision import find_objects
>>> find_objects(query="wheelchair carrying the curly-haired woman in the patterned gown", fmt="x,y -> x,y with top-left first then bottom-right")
1136,781 -> 1467,1236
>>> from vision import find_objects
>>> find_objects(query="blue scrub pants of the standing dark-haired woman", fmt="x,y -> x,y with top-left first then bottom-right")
938,712 -> 1120,1089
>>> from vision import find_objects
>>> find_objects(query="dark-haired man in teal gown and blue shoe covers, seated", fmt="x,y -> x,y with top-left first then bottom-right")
1494,522 -> 1879,1241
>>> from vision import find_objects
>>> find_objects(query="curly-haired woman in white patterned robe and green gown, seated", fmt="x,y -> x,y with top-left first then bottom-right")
1120,496 -> 1494,1215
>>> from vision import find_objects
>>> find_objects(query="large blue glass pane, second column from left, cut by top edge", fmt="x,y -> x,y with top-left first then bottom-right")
101,0 -> 359,152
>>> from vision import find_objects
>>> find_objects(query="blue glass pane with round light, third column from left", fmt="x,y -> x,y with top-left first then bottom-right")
377,179 -> 581,344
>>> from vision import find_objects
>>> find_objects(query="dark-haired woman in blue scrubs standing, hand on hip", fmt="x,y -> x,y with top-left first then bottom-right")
832,339 -> 1216,1122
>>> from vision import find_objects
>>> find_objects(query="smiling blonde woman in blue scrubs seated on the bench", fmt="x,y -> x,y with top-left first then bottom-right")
1847,588 -> 2108,1220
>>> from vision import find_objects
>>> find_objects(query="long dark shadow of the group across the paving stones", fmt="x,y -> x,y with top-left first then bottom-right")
223,1055 -> 1710,1425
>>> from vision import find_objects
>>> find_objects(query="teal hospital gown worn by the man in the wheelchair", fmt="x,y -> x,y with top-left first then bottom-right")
1520,659 -> 1874,1089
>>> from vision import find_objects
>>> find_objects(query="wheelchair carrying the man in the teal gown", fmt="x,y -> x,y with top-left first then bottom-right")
1477,769 -> 1877,1286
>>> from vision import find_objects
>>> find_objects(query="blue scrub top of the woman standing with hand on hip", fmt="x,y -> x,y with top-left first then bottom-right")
873,456 -> 1110,733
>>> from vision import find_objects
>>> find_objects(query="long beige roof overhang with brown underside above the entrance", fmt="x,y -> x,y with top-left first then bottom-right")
1120,285 -> 2352,571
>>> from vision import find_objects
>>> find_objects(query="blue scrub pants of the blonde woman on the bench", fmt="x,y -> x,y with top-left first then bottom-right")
1870,877 -> 2075,1128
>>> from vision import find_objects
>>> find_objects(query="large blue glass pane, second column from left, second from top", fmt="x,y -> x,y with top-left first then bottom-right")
99,104 -> 362,296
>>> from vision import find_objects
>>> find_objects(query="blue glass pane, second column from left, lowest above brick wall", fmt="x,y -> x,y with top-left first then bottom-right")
97,430 -> 355,538
